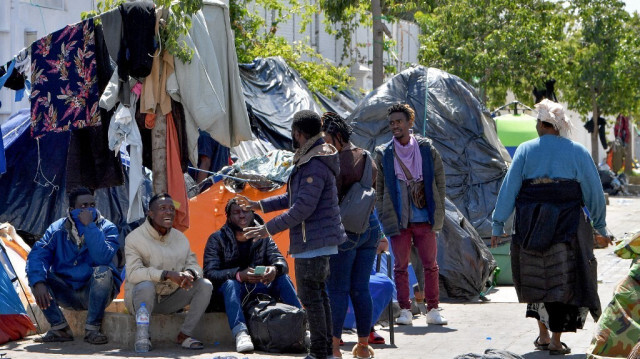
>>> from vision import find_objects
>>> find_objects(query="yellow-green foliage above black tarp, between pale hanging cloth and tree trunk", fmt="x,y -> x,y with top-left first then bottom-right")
230,0 -> 351,97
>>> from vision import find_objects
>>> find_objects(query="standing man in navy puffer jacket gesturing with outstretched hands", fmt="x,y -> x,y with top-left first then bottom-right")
241,111 -> 346,359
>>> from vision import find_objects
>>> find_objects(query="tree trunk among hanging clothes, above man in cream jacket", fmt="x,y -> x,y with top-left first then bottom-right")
151,111 -> 167,194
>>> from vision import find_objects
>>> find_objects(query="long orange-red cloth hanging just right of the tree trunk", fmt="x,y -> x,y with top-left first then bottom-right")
166,113 -> 189,232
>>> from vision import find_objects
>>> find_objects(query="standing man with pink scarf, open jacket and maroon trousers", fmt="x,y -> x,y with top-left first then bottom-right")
376,104 -> 447,325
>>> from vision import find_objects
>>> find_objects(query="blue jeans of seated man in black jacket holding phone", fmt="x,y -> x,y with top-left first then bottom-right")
216,274 -> 302,337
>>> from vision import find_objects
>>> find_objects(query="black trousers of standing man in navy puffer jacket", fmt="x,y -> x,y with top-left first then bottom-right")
294,256 -> 332,359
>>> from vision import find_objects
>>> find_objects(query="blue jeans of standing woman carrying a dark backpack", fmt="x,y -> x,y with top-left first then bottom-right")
327,214 -> 380,338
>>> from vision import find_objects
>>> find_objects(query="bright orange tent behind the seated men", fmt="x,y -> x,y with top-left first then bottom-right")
184,182 -> 296,283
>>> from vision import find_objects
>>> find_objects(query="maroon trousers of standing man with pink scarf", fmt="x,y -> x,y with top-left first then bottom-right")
391,223 -> 440,309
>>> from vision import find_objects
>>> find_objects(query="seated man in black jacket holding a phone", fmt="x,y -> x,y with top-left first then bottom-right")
204,198 -> 302,353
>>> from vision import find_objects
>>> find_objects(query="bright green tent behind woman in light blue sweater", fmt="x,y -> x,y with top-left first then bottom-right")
494,113 -> 538,157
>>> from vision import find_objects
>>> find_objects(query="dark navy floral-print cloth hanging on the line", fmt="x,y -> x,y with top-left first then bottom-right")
31,19 -> 100,138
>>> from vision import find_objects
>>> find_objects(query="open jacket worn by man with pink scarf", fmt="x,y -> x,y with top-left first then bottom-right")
375,136 -> 446,237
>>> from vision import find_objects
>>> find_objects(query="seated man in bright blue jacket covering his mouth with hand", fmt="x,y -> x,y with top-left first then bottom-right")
27,188 -> 122,344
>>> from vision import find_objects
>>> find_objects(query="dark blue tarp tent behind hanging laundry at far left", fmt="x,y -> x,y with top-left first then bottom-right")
0,109 -> 151,240
